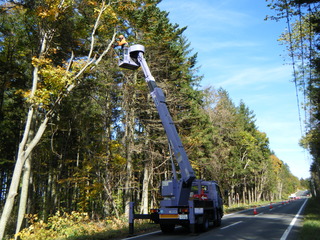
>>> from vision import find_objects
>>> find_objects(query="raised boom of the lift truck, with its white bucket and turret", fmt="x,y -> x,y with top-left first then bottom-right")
119,45 -> 195,199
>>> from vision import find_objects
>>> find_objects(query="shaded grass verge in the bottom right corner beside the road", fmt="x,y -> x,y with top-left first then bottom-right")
299,197 -> 320,240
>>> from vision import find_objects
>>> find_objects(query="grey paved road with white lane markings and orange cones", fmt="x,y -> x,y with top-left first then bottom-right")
127,199 -> 307,240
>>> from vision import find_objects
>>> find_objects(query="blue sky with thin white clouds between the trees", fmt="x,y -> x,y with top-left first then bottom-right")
158,0 -> 311,178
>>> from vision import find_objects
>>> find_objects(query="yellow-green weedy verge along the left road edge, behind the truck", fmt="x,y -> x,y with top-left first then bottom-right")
12,202 -> 284,240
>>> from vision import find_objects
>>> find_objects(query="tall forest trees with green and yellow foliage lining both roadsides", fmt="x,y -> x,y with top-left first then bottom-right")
0,0 -> 312,239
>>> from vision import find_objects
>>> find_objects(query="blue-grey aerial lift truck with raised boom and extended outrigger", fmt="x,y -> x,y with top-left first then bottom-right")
119,44 -> 223,234
